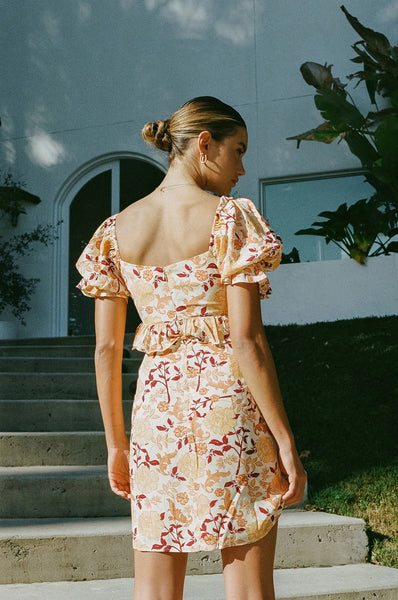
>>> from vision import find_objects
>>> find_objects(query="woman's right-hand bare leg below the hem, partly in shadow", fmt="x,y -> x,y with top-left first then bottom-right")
221,525 -> 277,600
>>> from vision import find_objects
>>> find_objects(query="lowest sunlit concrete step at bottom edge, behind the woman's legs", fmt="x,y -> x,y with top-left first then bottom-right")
1,564 -> 398,600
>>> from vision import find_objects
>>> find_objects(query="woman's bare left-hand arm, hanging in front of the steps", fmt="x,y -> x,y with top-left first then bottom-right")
95,298 -> 130,498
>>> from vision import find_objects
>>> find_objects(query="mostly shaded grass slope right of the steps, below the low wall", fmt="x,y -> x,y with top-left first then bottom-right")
265,317 -> 398,567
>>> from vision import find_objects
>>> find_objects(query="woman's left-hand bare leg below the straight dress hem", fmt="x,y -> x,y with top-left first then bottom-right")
133,550 -> 188,600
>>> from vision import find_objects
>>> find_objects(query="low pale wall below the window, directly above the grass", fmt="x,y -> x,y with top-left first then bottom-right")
261,254 -> 398,325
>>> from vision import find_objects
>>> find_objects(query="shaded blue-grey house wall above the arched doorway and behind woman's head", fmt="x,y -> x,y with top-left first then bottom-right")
0,0 -> 398,337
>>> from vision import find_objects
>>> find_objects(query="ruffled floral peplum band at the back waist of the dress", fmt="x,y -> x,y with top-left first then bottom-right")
133,315 -> 229,354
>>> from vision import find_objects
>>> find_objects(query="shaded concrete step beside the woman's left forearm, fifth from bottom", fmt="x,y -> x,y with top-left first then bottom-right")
0,399 -> 132,432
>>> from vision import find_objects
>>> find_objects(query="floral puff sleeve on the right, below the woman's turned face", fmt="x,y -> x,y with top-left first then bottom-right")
213,198 -> 282,298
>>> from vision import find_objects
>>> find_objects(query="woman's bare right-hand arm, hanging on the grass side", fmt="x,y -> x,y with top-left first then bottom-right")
227,283 -> 306,506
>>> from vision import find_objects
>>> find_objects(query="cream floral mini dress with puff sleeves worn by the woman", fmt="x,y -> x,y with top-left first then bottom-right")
76,196 -> 288,552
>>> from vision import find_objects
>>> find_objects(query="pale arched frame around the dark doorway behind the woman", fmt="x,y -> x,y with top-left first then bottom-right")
51,152 -> 167,337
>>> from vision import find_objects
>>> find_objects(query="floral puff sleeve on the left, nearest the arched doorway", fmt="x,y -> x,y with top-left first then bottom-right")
76,216 -> 130,300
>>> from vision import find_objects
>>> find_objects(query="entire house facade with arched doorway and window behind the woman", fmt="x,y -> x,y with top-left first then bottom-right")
0,0 -> 398,337
